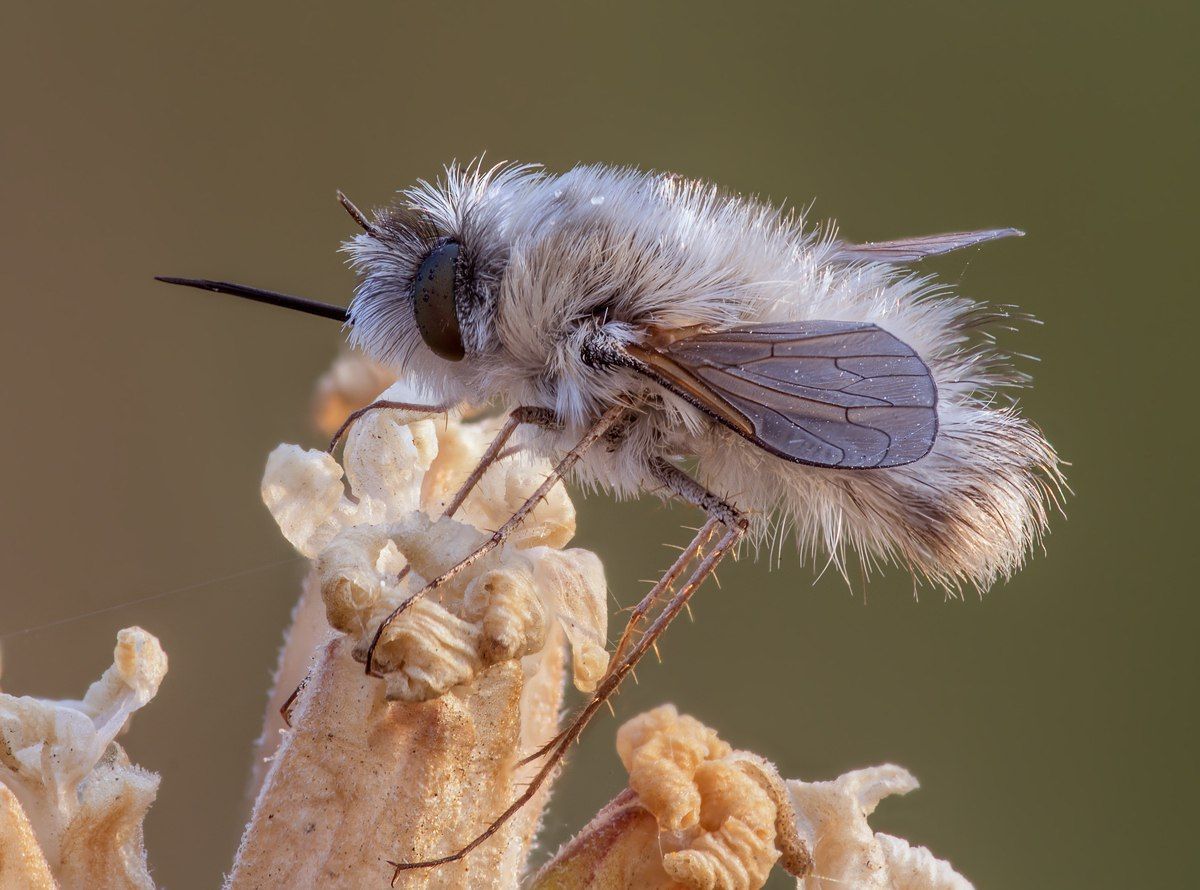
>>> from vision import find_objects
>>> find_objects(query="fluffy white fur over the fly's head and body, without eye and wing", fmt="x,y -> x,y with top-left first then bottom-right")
348,166 -> 1061,588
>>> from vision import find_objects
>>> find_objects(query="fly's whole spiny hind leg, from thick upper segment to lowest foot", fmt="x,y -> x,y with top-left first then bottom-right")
388,461 -> 749,884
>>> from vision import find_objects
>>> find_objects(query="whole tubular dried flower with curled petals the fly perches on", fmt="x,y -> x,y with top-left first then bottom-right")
229,400 -> 607,889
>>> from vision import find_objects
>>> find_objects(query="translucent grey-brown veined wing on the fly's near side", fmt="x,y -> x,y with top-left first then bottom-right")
659,321 -> 937,469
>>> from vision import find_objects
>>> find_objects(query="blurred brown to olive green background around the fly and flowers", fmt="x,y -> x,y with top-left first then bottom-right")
0,1 -> 1200,889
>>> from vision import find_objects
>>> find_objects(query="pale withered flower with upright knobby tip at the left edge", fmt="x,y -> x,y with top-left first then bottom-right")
0,627 -> 167,888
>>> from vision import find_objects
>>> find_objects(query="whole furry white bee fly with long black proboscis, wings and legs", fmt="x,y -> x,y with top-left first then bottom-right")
157,166 -> 1061,868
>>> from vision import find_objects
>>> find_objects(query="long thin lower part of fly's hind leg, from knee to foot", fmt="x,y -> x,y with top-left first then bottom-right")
388,521 -> 745,885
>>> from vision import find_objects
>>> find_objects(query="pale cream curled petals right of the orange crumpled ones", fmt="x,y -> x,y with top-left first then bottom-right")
787,764 -> 971,890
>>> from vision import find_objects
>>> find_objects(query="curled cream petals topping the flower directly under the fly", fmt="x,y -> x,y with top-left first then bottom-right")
256,393 -> 607,702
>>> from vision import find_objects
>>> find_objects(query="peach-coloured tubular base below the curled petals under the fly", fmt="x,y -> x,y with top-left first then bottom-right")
228,637 -> 565,890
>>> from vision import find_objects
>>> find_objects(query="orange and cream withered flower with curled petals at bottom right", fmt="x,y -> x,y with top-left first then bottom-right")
533,705 -> 971,890
